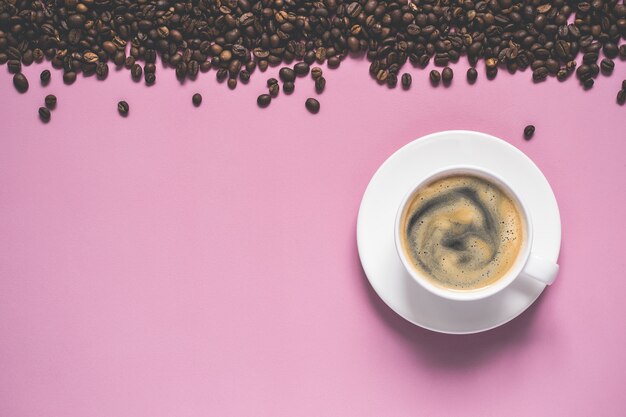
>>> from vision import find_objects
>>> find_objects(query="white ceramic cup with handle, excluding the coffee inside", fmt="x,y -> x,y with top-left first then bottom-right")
394,165 -> 559,301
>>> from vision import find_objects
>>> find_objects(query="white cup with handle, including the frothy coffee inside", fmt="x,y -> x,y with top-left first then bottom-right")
394,166 -> 559,301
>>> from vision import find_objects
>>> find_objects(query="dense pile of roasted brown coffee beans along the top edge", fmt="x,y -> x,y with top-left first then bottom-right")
0,0 -> 626,114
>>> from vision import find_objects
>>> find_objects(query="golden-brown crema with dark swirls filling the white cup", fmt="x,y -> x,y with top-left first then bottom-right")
400,174 -> 525,291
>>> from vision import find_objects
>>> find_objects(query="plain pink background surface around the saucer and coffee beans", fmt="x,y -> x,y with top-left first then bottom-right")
0,61 -> 626,417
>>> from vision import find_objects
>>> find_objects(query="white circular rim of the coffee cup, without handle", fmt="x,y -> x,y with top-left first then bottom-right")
394,164 -> 533,301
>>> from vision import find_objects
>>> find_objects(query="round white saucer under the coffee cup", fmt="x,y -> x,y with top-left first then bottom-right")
357,130 -> 561,334
